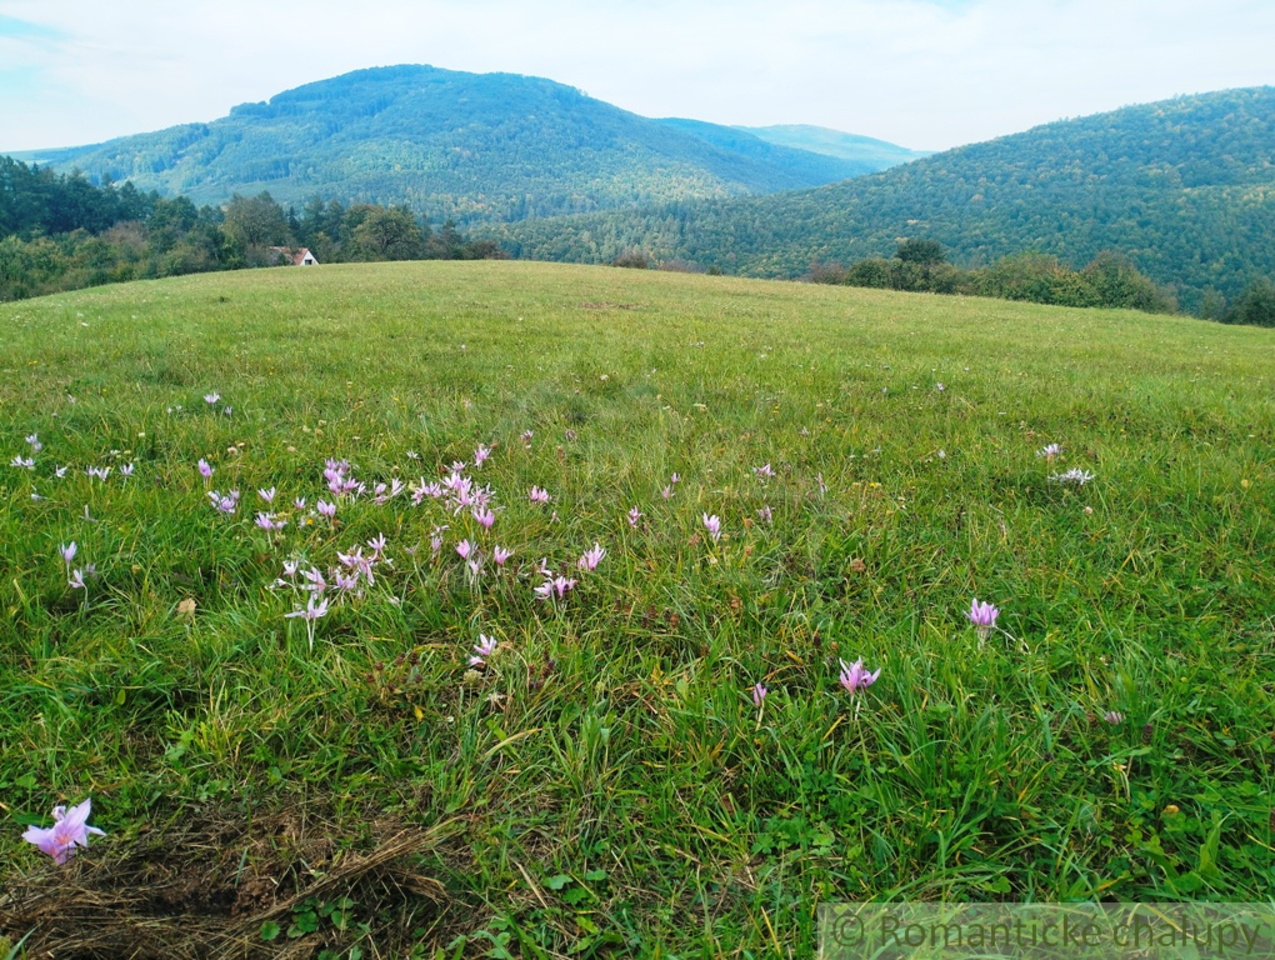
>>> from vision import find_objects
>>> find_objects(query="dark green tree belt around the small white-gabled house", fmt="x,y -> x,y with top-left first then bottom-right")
0,157 -> 502,301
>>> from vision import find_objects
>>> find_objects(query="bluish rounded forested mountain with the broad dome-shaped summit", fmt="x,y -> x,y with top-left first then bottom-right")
4,66 -> 912,223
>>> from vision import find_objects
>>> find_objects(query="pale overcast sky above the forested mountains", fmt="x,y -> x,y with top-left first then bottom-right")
0,0 -> 1275,150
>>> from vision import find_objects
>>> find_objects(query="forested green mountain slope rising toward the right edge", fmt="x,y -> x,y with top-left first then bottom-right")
486,87 -> 1275,311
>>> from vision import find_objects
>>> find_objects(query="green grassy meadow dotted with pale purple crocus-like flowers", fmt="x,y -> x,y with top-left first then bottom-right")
0,263 -> 1275,959
